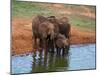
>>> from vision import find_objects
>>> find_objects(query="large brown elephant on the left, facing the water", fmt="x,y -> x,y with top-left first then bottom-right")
32,15 -> 55,48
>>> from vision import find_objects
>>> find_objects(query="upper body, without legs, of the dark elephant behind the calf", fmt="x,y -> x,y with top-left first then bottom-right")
48,16 -> 71,39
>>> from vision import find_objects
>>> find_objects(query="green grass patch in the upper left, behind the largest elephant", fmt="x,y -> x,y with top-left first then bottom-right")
12,0 -> 57,17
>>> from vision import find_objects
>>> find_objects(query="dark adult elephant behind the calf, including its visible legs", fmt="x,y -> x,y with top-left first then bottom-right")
47,16 -> 71,53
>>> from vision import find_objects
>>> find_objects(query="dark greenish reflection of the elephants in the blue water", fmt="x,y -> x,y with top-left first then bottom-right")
32,50 -> 68,73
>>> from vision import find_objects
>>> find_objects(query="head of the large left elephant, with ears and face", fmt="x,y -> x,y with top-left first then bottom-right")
38,21 -> 55,39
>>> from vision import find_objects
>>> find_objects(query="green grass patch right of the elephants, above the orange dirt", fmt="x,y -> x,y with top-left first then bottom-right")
69,15 -> 96,31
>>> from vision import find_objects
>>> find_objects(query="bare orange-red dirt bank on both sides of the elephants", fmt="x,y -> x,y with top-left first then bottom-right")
11,18 -> 95,55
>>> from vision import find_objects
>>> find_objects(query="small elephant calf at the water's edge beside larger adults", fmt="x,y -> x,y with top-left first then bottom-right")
55,34 -> 69,55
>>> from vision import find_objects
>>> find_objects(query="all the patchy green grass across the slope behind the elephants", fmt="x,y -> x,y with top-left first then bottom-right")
12,0 -> 95,30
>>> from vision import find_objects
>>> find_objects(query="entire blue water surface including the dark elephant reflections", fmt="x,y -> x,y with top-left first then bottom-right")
11,44 -> 96,74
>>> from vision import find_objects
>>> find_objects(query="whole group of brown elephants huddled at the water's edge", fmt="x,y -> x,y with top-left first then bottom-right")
32,15 -> 70,53
